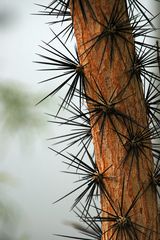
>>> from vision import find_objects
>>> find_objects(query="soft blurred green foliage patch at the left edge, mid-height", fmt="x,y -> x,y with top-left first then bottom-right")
0,82 -> 42,134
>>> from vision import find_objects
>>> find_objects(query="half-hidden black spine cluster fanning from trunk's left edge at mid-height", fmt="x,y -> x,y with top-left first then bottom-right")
49,102 -> 92,159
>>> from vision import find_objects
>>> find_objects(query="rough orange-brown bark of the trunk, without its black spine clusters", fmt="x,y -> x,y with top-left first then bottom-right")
70,0 -> 158,239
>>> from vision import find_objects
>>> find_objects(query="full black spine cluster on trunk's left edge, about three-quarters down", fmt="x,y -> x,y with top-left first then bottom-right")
51,144 -> 113,214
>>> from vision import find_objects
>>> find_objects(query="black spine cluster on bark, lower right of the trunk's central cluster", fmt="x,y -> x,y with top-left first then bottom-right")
118,116 -> 160,178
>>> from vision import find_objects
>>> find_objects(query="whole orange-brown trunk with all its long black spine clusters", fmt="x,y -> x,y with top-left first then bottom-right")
37,0 -> 160,240
